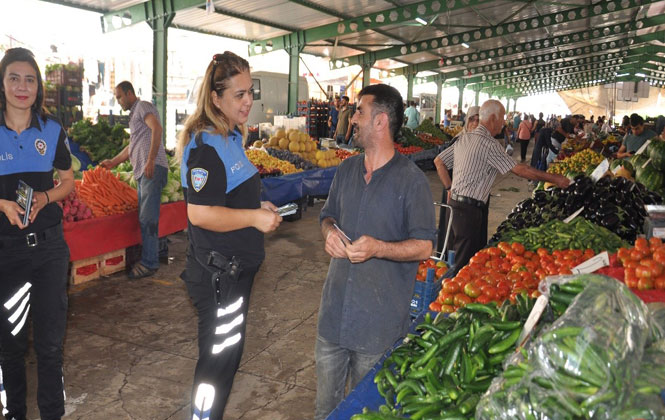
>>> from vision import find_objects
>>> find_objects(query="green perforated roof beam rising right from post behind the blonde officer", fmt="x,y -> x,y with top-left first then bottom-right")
249,0 -> 496,55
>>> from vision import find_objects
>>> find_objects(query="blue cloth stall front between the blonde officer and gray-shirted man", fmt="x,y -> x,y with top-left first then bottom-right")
261,166 -> 337,206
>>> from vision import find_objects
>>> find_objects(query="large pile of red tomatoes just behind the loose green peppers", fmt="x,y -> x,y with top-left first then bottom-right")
429,242 -> 595,313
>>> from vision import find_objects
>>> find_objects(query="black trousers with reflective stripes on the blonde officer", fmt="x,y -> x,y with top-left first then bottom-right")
181,255 -> 260,420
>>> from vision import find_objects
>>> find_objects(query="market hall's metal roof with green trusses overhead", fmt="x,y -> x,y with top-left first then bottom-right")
44,0 -> 665,97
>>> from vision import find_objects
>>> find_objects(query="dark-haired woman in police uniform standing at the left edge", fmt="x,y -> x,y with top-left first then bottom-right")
0,48 -> 74,420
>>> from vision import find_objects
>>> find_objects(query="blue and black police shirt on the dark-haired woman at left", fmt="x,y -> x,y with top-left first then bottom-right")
0,112 -> 72,236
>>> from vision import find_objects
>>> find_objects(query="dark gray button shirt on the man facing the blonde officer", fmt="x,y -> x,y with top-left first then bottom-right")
318,153 -> 436,354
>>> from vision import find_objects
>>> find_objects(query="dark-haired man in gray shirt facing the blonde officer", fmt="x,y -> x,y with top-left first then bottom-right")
315,84 -> 436,420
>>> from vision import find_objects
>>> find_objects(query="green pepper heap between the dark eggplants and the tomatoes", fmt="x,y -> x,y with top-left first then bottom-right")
500,216 -> 628,253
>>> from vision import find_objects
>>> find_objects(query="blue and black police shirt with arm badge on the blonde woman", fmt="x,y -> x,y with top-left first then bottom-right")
180,130 -> 265,265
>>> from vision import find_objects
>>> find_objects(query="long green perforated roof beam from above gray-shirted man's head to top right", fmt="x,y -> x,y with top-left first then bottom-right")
334,0 -> 658,65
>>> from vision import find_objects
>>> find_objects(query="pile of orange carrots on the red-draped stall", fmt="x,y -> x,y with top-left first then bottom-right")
76,166 -> 138,217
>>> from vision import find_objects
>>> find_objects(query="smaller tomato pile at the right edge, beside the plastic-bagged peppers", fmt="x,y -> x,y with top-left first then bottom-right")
617,238 -> 665,290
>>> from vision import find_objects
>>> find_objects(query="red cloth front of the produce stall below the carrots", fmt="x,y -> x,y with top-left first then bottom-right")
64,201 -> 187,261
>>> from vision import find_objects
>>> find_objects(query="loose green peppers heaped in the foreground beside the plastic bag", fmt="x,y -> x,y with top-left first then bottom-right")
352,295 -> 535,420
